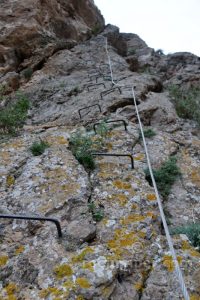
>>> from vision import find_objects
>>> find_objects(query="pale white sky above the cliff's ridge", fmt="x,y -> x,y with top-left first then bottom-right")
94,0 -> 200,56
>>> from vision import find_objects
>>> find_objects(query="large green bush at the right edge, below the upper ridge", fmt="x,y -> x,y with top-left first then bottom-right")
169,85 -> 200,126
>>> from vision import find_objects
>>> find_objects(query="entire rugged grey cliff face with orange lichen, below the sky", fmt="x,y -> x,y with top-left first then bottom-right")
0,0 -> 200,300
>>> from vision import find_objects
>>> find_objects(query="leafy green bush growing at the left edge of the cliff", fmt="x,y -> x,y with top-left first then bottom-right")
0,92 -> 30,134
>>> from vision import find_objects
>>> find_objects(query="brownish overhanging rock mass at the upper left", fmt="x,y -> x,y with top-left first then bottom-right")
0,0 -> 104,78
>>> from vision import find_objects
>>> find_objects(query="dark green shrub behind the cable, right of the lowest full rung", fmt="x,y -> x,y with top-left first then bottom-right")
145,156 -> 181,198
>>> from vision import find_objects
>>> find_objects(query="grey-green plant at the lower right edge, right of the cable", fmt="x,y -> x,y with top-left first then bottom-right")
170,223 -> 200,251
